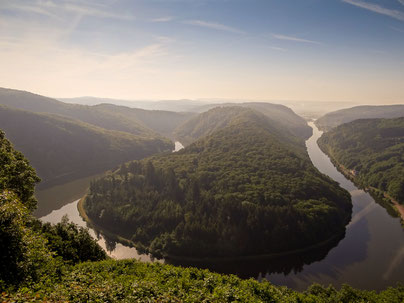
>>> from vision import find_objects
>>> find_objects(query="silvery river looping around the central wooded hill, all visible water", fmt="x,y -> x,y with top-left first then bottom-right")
36,130 -> 404,290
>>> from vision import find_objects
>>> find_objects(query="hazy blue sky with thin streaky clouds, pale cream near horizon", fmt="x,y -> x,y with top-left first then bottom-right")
0,0 -> 404,103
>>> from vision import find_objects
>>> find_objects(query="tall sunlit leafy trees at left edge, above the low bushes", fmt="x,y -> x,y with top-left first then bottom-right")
0,132 -> 106,291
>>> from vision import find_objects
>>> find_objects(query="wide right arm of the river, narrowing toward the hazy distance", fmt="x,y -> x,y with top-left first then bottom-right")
266,123 -> 404,290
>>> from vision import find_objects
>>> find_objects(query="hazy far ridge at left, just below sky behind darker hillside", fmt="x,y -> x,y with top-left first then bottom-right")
0,88 -> 192,137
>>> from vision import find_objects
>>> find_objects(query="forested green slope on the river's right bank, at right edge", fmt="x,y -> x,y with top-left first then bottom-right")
318,118 -> 404,203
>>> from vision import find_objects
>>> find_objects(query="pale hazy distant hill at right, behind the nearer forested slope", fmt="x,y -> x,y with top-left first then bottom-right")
315,104 -> 404,131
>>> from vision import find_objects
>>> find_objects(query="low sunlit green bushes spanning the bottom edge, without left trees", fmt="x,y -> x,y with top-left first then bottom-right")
1,260 -> 404,303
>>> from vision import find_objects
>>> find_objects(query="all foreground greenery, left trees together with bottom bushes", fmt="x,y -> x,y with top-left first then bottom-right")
0,108 -> 404,303
